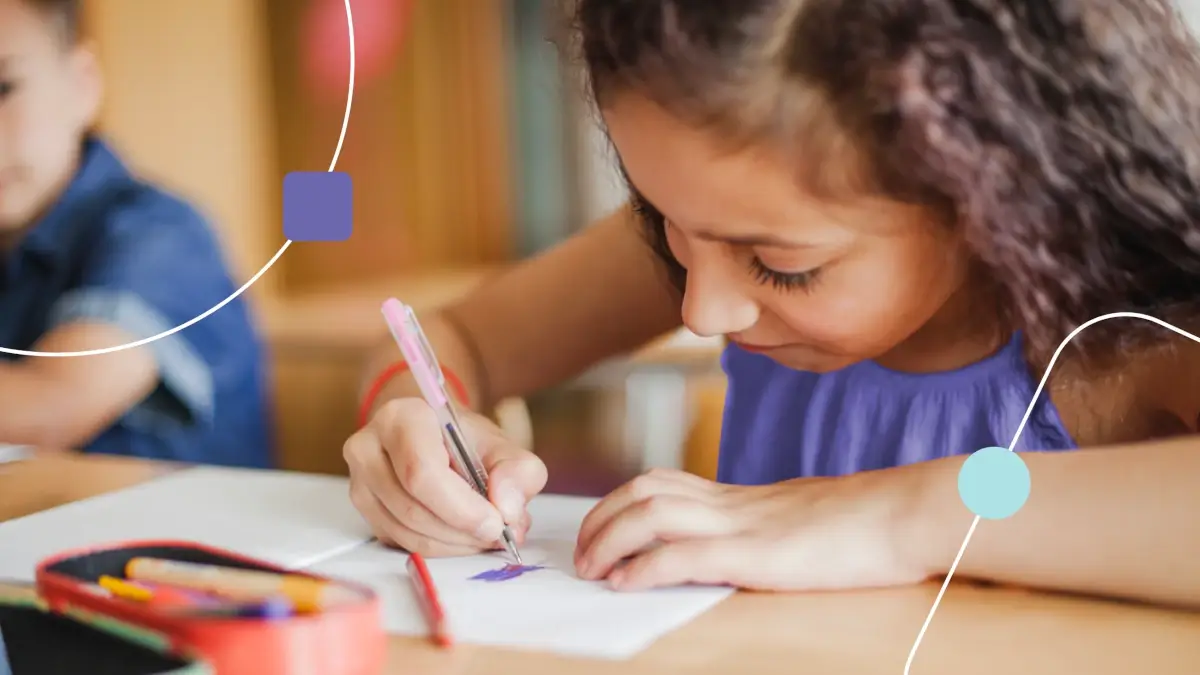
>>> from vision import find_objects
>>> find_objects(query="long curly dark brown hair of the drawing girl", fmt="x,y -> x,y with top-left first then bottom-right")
570,0 -> 1200,362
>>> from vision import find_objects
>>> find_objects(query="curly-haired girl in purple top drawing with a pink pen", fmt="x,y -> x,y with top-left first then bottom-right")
346,0 -> 1200,602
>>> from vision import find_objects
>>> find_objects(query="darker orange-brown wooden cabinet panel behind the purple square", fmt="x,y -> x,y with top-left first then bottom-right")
265,0 -> 512,292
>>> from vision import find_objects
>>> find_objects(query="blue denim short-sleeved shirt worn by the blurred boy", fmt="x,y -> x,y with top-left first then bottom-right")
0,138 -> 274,467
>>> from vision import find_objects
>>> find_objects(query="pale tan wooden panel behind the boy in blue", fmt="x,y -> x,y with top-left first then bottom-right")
84,0 -> 284,295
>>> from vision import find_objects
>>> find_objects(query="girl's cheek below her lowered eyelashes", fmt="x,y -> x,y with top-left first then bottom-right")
772,236 -> 964,359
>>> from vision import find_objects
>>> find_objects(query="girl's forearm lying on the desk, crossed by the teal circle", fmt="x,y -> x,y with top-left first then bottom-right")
905,437 -> 1200,607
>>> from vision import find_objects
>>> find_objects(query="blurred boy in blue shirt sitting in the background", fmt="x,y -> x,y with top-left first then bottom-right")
0,0 -> 271,466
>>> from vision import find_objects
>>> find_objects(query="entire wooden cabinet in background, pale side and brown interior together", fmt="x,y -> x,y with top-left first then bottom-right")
84,0 -> 514,472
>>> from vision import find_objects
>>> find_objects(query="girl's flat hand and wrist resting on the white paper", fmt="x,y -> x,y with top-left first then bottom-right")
575,468 -> 936,591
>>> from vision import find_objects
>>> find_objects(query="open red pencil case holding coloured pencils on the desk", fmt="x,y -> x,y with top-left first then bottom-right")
36,542 -> 386,675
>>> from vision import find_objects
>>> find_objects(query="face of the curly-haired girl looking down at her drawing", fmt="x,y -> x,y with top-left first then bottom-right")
604,95 -> 970,372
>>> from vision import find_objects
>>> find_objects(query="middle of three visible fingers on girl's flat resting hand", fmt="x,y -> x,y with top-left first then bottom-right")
577,495 -> 732,579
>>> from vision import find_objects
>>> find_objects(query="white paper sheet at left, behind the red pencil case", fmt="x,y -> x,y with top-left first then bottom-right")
0,467 -> 371,580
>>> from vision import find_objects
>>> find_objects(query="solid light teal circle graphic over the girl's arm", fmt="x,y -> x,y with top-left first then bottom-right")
959,448 -> 1031,520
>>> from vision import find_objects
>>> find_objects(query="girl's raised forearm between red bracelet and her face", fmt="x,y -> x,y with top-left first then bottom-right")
352,204 -> 682,412
